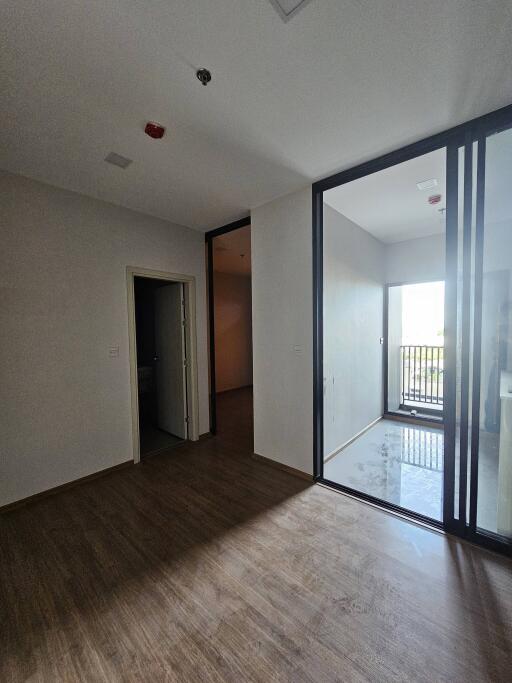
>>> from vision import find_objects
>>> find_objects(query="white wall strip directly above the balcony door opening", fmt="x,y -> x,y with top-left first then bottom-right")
385,233 -> 445,284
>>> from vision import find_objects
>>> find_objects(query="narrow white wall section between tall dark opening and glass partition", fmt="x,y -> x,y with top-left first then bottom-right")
251,187 -> 313,474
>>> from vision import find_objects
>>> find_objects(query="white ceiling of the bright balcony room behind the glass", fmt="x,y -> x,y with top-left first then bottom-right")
324,149 -> 446,244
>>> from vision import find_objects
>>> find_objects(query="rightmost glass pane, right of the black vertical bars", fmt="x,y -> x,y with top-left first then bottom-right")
477,129 -> 512,538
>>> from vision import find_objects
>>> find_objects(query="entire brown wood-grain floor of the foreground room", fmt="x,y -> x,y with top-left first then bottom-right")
0,388 -> 512,683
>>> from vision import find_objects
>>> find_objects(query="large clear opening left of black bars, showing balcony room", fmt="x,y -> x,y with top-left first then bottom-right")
323,149 -> 446,520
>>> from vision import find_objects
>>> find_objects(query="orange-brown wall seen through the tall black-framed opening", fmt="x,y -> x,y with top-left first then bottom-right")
214,273 -> 252,392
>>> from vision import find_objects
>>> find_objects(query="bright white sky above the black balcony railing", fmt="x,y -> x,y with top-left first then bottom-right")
402,281 -> 444,346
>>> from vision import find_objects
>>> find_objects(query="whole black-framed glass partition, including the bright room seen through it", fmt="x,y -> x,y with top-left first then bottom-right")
313,107 -> 512,553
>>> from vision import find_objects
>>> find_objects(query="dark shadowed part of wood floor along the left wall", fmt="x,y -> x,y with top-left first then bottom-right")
0,384 -> 310,680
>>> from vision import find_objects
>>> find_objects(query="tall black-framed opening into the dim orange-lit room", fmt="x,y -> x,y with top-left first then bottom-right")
207,221 -> 253,452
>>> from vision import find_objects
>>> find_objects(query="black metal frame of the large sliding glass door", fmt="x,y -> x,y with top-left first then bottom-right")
312,105 -> 512,553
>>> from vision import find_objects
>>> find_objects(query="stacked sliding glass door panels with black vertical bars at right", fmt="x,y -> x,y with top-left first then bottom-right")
445,121 -> 512,548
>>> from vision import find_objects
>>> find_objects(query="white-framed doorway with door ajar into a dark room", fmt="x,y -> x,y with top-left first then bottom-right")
127,268 -> 198,462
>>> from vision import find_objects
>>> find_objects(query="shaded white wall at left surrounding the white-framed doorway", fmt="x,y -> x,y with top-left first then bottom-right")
0,172 -> 209,505
